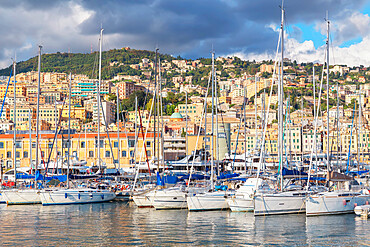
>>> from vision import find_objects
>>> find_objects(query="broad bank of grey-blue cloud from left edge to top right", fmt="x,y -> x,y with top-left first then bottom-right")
0,0 -> 366,68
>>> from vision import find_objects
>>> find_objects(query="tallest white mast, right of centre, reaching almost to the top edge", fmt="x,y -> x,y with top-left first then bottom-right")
278,5 -> 284,190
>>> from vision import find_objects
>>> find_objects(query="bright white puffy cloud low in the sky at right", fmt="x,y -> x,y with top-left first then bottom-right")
232,12 -> 370,66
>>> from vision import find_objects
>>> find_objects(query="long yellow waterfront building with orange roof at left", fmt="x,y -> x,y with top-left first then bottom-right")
0,133 -> 161,169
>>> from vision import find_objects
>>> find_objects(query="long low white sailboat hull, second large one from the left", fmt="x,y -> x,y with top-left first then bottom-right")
40,189 -> 116,205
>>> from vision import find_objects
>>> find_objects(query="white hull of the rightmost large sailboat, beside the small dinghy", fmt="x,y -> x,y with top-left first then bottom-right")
306,192 -> 370,216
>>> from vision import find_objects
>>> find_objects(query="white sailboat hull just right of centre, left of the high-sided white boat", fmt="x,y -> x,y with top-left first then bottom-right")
187,192 -> 229,211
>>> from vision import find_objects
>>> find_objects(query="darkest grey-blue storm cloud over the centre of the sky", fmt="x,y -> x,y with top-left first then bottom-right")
74,0 -> 365,57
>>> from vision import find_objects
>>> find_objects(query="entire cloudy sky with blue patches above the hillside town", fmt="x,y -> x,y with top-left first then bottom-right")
0,0 -> 370,68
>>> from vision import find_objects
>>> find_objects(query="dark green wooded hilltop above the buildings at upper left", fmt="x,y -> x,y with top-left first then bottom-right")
0,49 -> 175,79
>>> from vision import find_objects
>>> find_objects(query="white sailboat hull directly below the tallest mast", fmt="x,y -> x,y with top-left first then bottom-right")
254,194 -> 306,216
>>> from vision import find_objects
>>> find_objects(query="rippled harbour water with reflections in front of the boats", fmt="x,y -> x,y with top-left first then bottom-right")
0,202 -> 370,246
